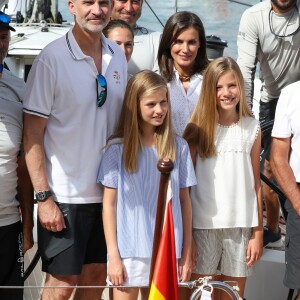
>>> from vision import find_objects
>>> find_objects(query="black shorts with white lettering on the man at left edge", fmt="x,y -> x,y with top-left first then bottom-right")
0,221 -> 24,300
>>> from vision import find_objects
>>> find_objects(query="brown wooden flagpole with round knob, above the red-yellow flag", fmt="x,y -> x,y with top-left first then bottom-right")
149,159 -> 174,285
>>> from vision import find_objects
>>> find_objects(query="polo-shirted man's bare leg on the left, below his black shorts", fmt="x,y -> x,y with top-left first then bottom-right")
41,274 -> 78,300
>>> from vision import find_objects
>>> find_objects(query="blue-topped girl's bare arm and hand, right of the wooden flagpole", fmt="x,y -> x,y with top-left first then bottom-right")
178,188 -> 193,281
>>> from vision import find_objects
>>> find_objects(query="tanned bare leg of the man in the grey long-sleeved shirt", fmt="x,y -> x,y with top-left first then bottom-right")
263,160 -> 279,232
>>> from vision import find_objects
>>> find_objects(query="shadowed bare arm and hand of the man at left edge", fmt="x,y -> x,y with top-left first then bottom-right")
17,150 -> 34,253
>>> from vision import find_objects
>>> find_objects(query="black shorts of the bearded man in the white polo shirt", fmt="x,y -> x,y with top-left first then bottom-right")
38,203 -> 107,275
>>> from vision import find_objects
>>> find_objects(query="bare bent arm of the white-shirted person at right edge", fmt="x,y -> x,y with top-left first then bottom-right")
271,137 -> 300,215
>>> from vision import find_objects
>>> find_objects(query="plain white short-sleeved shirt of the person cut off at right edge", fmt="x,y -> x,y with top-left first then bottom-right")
272,81 -> 300,182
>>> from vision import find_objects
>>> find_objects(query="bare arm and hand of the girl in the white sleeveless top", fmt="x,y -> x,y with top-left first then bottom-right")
247,131 -> 263,266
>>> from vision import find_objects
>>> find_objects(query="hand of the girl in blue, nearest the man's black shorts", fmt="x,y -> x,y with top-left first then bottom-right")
107,256 -> 127,285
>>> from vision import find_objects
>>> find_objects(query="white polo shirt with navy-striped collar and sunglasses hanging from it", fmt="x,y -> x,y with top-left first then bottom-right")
24,30 -> 127,204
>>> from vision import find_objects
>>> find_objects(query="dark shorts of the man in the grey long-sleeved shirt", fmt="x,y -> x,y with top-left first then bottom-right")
259,99 -> 278,161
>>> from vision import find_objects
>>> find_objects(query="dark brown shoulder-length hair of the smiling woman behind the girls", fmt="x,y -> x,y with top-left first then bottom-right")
157,11 -> 208,82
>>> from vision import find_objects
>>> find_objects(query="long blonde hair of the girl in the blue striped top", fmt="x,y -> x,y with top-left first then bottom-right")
111,70 -> 176,173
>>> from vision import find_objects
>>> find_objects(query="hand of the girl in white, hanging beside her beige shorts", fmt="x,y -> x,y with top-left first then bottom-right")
246,229 -> 263,267
